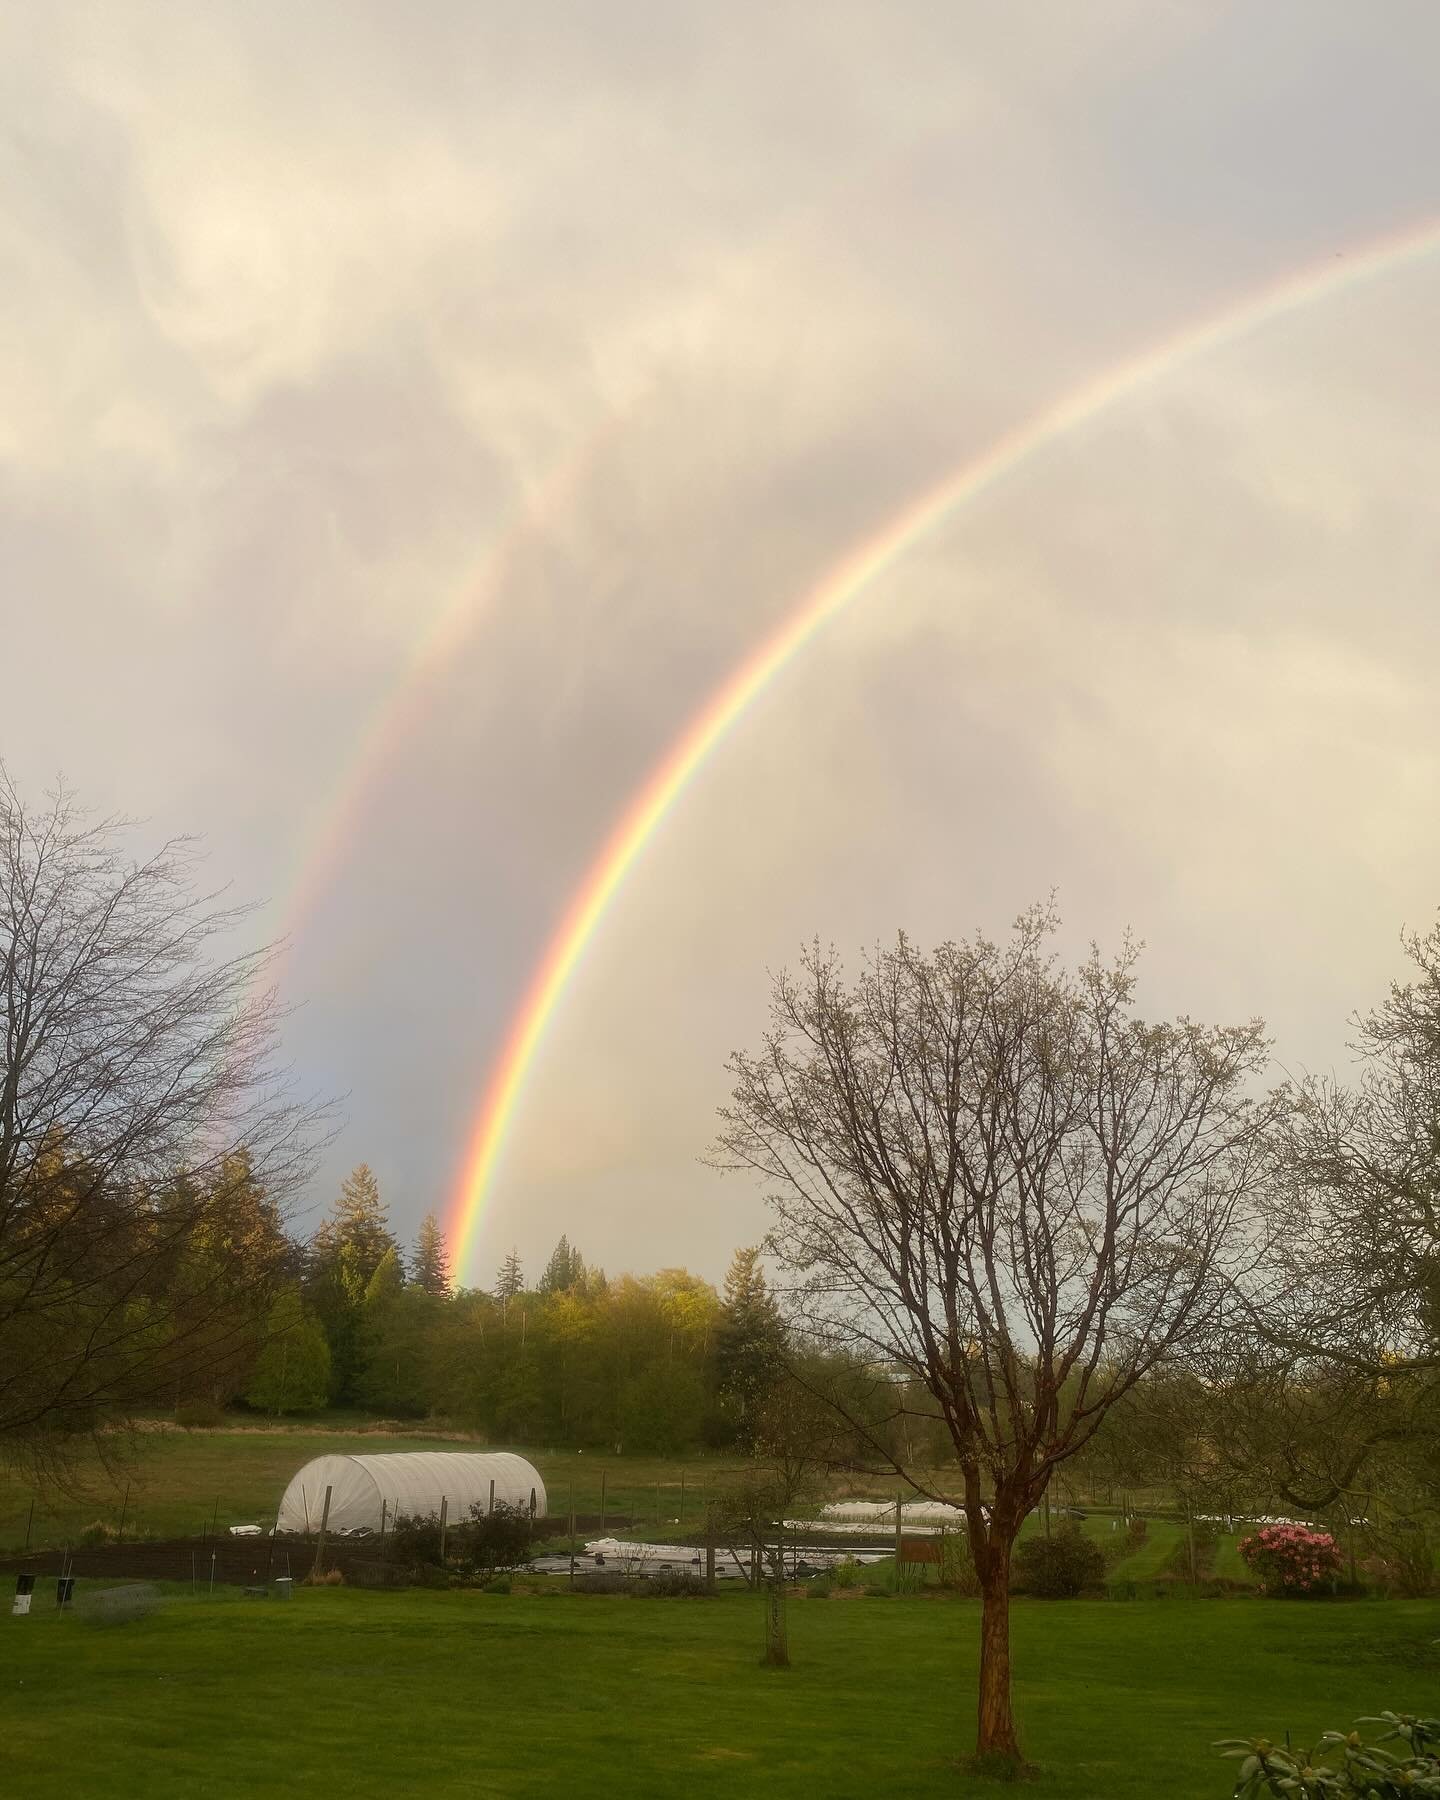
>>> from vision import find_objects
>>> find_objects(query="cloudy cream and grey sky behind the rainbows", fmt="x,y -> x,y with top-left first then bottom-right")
0,0 -> 1440,1280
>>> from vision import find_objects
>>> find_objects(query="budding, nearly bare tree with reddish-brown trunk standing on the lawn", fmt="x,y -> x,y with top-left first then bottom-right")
715,907 -> 1280,1759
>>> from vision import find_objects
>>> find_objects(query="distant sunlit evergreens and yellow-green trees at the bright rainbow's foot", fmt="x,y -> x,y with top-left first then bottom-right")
246,1165 -> 785,1454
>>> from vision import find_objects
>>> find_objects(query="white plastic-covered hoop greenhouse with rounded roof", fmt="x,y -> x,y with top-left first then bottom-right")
275,1451 -> 545,1534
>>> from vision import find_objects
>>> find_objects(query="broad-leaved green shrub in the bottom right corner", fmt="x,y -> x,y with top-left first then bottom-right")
1215,1712 -> 1440,1800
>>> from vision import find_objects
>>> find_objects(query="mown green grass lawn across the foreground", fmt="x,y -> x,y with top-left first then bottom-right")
0,1589 -> 1440,1800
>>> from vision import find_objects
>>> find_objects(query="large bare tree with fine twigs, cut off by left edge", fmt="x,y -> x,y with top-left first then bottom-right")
0,769 -> 324,1462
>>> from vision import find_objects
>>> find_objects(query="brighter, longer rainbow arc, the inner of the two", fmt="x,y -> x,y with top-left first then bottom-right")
448,221 -> 1440,1280
